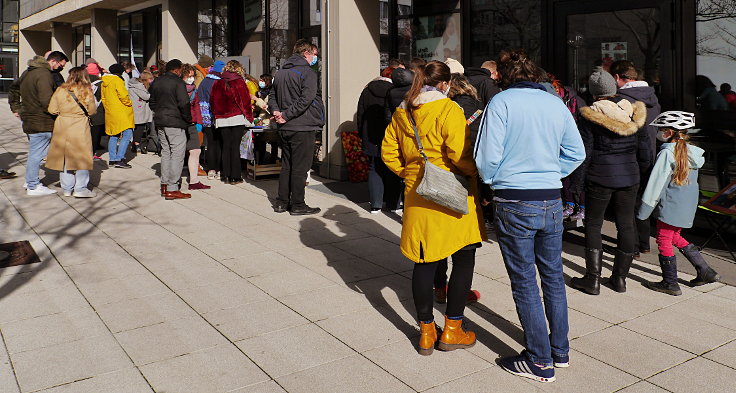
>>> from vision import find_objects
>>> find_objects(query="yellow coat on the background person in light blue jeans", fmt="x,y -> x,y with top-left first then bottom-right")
102,75 -> 135,135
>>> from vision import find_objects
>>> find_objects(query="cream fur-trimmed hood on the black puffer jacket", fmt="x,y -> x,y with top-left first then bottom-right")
580,99 -> 647,136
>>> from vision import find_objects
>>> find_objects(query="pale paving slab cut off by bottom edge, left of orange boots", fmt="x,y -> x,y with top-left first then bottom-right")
277,355 -> 414,393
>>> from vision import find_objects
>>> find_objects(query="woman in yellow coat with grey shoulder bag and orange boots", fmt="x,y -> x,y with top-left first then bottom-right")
381,61 -> 485,355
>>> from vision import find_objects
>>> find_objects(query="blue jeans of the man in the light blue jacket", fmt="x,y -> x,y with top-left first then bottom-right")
496,199 -> 570,365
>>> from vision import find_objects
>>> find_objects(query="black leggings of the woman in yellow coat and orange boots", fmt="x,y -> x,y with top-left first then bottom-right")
411,248 -> 475,322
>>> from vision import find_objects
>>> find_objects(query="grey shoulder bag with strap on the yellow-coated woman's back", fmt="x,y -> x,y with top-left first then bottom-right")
407,113 -> 468,215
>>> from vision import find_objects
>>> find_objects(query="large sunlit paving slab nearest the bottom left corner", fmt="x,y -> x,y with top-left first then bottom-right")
12,334 -> 132,392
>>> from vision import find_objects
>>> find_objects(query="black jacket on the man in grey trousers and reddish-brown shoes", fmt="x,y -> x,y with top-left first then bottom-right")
149,72 -> 192,129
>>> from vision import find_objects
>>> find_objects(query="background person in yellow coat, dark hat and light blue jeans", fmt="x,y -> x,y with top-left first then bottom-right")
102,64 -> 135,168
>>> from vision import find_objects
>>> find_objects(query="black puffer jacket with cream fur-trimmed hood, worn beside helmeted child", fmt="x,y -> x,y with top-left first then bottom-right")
578,97 -> 651,188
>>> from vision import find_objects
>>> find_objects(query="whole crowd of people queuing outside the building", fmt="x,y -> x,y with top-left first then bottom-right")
2,40 -> 719,382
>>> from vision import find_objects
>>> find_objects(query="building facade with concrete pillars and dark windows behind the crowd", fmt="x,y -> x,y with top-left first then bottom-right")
14,0 -> 736,178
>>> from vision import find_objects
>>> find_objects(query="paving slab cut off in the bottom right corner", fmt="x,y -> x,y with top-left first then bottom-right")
649,357 -> 736,393
